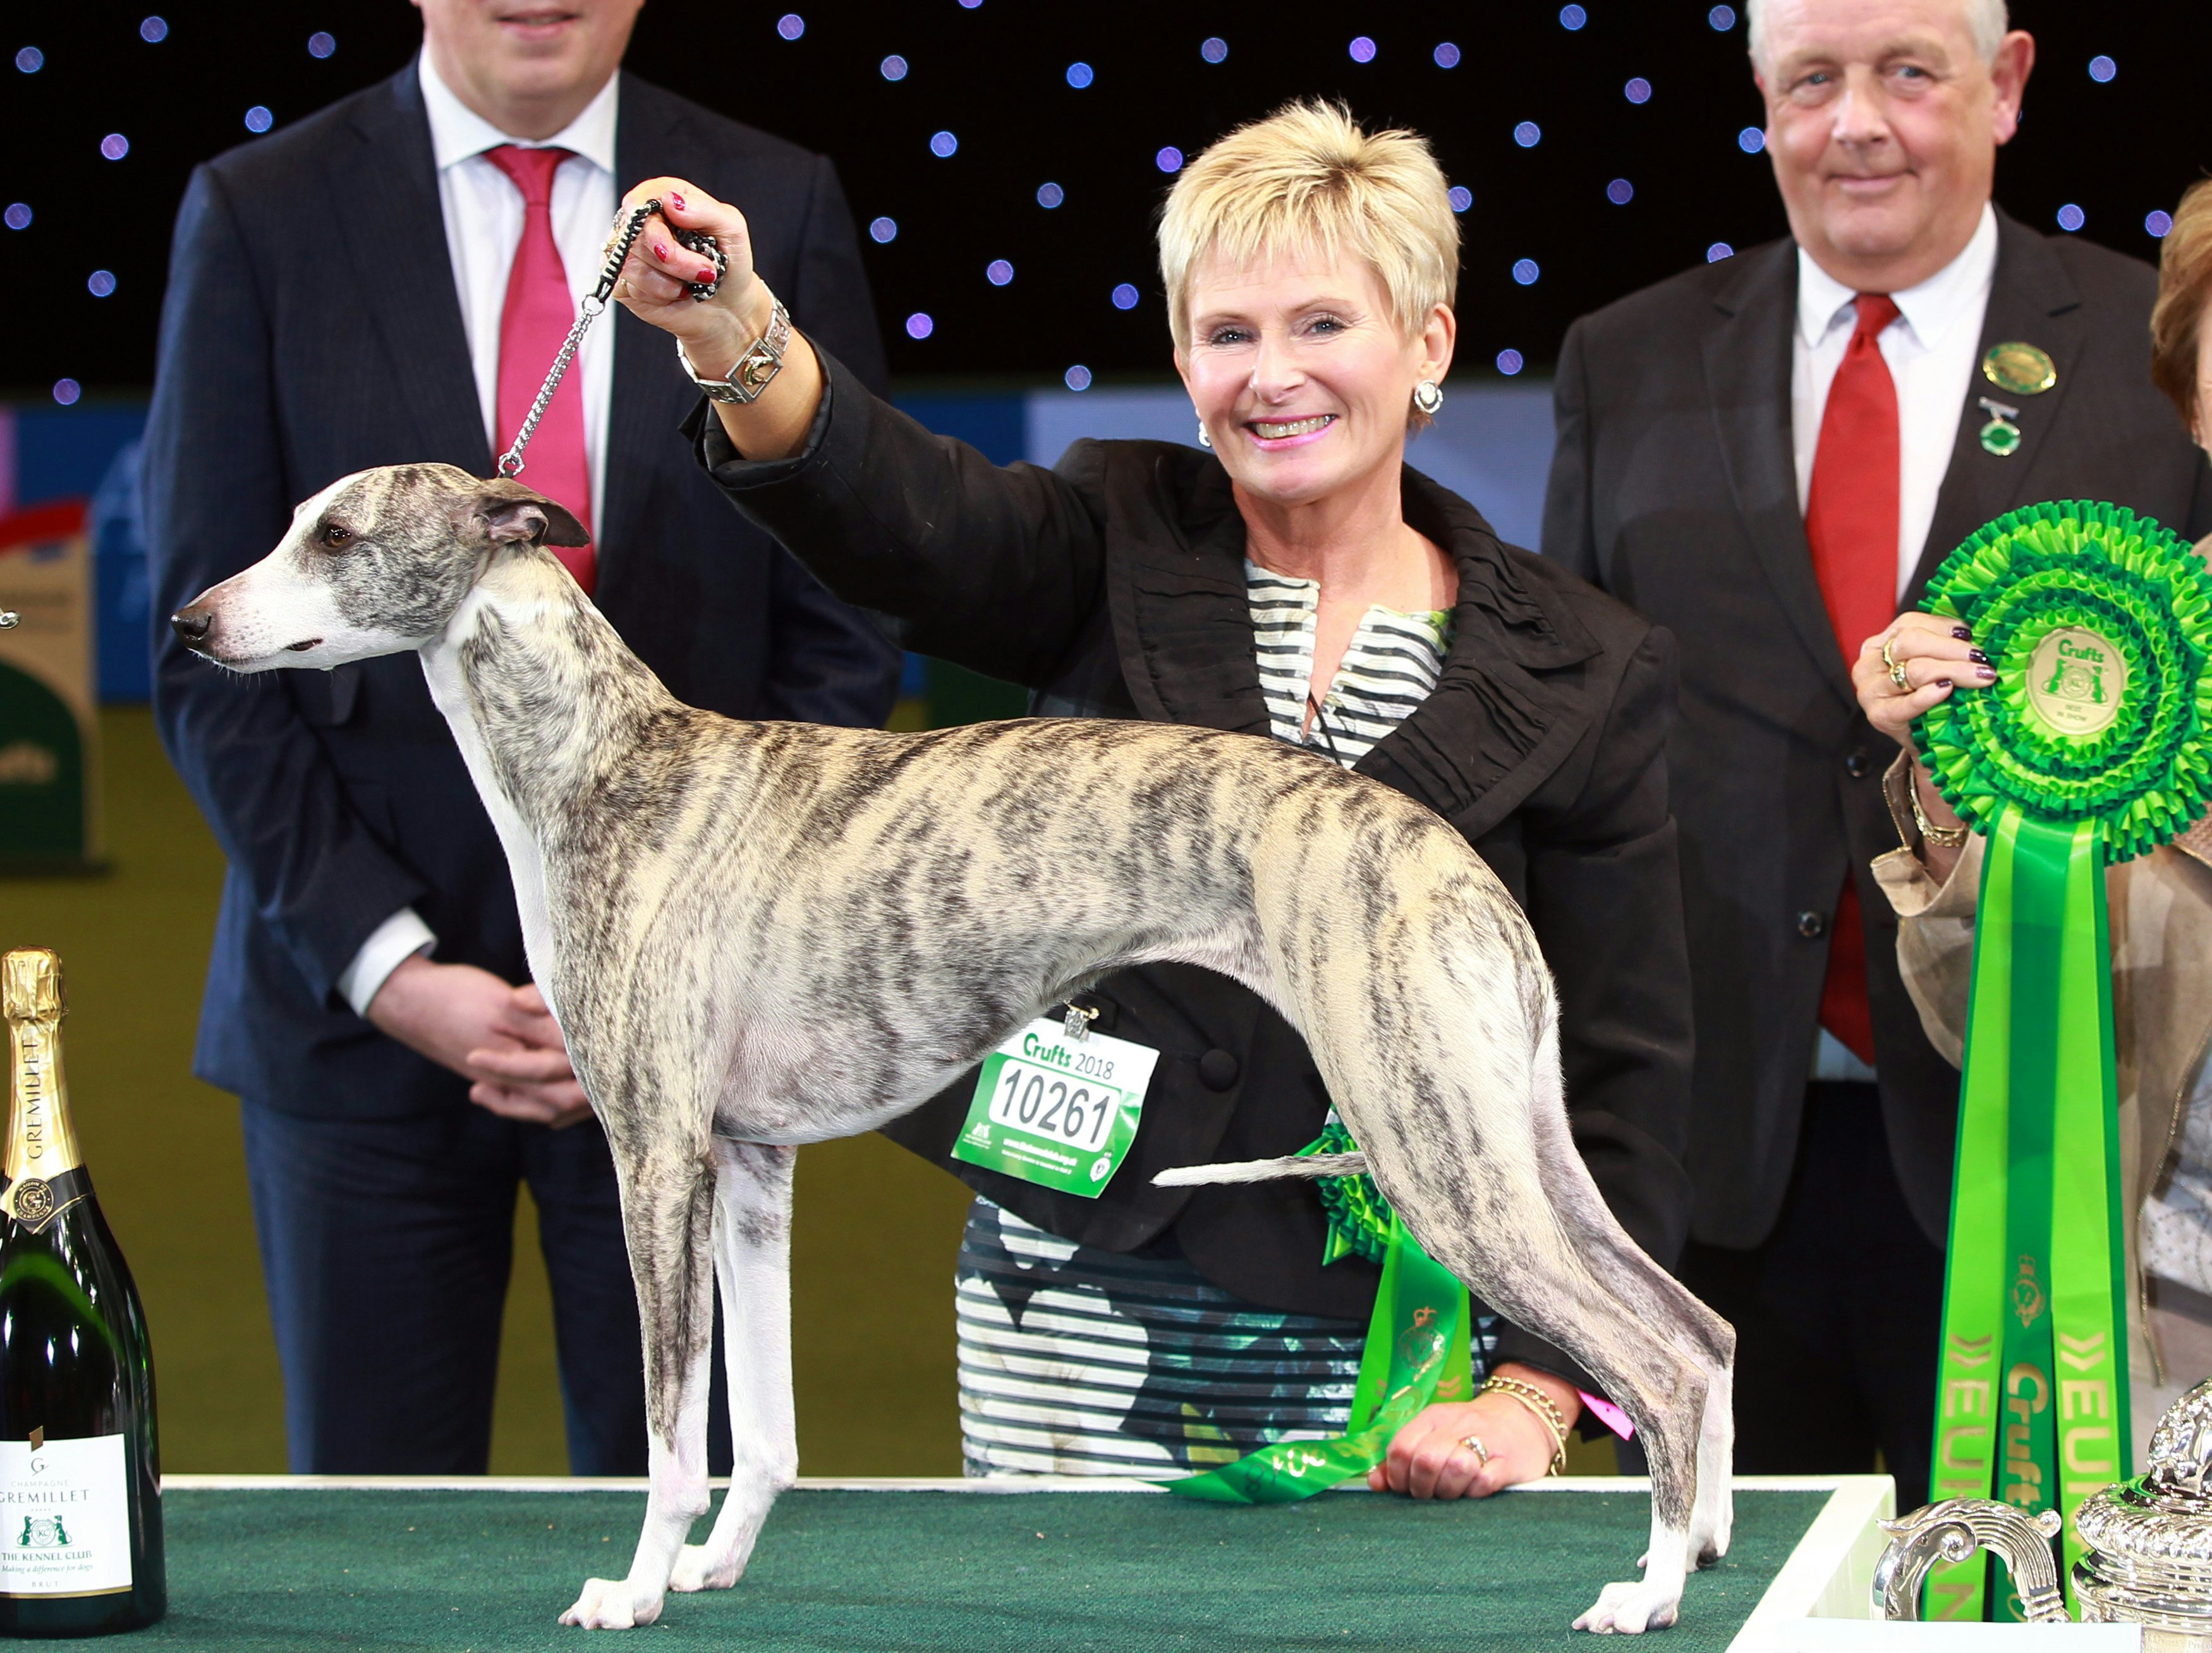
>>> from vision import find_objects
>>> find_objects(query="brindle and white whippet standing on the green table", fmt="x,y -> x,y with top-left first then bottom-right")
173,464 -> 1734,1631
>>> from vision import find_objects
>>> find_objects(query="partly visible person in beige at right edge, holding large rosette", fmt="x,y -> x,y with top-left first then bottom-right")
1852,179 -> 2212,1467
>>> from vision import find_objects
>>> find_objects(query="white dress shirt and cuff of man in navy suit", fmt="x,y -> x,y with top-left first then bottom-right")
339,51 -> 622,1015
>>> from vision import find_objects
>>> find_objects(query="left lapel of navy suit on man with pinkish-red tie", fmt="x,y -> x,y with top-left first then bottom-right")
327,62 -> 491,476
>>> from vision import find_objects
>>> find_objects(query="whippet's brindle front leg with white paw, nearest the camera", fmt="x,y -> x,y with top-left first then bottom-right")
560,1131 -> 715,1631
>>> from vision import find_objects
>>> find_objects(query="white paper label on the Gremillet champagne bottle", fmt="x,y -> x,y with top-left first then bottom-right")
0,1434 -> 131,1595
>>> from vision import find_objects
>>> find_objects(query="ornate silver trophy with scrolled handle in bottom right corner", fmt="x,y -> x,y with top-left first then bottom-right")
1874,1381 -> 2212,1653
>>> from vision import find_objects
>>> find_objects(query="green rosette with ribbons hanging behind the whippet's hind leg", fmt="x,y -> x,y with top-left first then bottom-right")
1164,1113 -> 1473,1505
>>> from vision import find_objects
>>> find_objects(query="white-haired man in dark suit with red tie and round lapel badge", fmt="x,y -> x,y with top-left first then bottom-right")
1544,0 -> 2212,1509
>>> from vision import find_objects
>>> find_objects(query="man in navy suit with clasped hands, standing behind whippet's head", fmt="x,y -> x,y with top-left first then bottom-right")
146,0 -> 896,1474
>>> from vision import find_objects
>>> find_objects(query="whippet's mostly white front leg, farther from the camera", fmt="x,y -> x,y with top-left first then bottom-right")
668,1140 -> 799,1591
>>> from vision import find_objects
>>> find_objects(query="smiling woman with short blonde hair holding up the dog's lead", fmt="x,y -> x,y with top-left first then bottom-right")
617,104 -> 1690,1498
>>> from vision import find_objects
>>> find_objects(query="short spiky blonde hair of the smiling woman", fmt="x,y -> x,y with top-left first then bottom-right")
1159,100 -> 1460,349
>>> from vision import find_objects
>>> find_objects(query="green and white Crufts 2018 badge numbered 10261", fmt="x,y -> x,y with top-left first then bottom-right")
954,1018 -> 1159,1197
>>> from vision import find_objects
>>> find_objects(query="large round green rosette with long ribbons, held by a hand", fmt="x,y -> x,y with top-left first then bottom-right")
1914,500 -> 2212,1620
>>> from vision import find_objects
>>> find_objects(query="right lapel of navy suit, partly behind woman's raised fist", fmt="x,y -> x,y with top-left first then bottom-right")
595,73 -> 712,584
